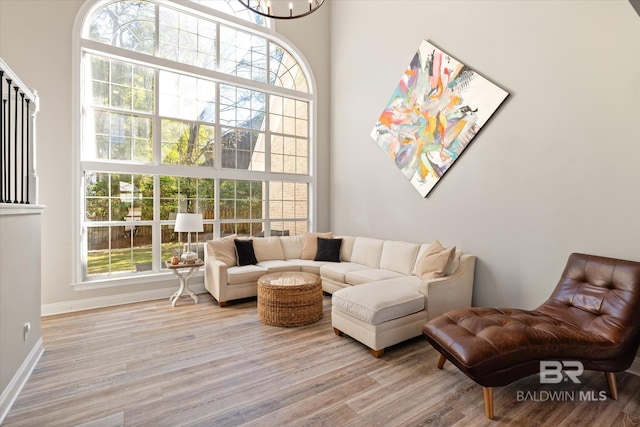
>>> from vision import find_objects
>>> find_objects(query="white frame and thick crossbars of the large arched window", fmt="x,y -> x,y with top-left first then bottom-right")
71,0 -> 317,290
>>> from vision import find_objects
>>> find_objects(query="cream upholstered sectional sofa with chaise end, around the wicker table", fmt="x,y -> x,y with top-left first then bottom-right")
204,233 -> 475,357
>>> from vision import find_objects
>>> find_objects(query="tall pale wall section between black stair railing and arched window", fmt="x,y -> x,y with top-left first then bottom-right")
0,0 -> 80,308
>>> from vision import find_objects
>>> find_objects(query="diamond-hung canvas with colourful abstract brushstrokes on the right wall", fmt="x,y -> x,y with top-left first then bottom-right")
371,41 -> 508,197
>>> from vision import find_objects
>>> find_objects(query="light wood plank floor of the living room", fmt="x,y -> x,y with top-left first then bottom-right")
3,295 -> 640,427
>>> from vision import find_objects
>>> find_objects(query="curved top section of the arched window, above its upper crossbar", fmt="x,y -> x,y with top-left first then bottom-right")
82,0 -> 310,93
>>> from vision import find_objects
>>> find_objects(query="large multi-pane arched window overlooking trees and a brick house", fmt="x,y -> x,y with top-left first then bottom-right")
78,0 -> 314,282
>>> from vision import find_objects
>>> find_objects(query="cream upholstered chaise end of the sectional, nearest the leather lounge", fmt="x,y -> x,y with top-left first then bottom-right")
331,279 -> 427,357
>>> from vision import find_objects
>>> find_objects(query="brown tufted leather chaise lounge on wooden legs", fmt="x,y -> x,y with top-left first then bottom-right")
422,254 -> 640,419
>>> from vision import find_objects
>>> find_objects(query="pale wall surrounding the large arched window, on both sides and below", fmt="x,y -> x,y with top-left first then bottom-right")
0,0 -> 329,311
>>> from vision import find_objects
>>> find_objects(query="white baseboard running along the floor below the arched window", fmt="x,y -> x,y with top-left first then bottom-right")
40,283 -> 206,316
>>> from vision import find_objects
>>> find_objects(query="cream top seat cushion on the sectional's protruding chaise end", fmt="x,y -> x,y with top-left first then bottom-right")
331,282 -> 424,325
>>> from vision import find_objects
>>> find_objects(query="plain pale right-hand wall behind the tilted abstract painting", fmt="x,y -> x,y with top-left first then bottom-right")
331,0 -> 640,308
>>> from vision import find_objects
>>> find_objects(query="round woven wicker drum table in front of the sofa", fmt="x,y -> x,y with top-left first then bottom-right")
258,272 -> 322,327
